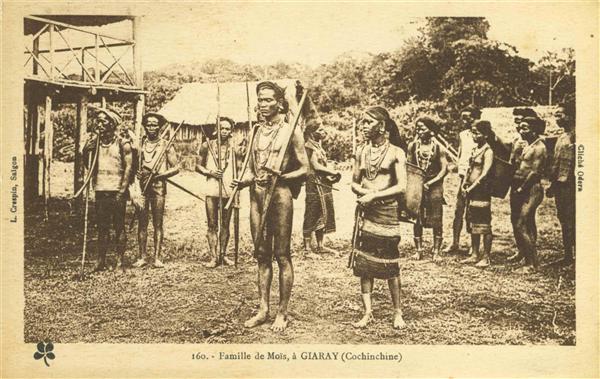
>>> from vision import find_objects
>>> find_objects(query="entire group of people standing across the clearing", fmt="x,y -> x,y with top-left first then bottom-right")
84,81 -> 575,331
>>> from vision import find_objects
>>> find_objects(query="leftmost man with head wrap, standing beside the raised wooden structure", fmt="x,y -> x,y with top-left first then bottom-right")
83,108 -> 132,271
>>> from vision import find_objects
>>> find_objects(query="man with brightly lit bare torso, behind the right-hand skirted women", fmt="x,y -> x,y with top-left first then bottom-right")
443,106 -> 481,253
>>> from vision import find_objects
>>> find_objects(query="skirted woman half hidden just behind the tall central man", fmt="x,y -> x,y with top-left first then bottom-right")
302,128 -> 341,258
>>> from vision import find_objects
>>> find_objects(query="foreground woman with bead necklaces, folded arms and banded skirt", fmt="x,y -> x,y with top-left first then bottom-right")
352,107 -> 406,329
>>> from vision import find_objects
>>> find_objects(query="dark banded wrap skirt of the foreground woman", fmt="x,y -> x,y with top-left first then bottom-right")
353,199 -> 400,279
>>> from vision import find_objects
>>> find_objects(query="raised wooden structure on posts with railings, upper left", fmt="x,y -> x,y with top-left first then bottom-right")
24,15 -> 147,215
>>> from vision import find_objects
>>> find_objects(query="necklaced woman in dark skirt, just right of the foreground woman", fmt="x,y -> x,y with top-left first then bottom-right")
408,117 -> 447,260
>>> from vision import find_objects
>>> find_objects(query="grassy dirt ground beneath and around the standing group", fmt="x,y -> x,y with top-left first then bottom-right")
24,164 -> 575,345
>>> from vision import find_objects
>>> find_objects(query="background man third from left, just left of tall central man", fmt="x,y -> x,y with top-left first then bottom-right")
196,117 -> 244,268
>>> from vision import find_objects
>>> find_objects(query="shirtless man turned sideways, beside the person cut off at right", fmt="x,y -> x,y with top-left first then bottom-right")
509,117 -> 547,268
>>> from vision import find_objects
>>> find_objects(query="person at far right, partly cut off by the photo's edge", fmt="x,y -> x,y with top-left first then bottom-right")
546,101 -> 576,264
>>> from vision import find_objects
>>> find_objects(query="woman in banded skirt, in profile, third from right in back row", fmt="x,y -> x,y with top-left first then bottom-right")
461,120 -> 494,267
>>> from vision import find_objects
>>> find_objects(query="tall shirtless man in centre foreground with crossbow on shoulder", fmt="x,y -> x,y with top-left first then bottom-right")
232,82 -> 308,332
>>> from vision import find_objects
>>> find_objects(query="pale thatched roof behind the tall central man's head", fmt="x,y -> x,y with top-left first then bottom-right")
158,79 -> 297,125
